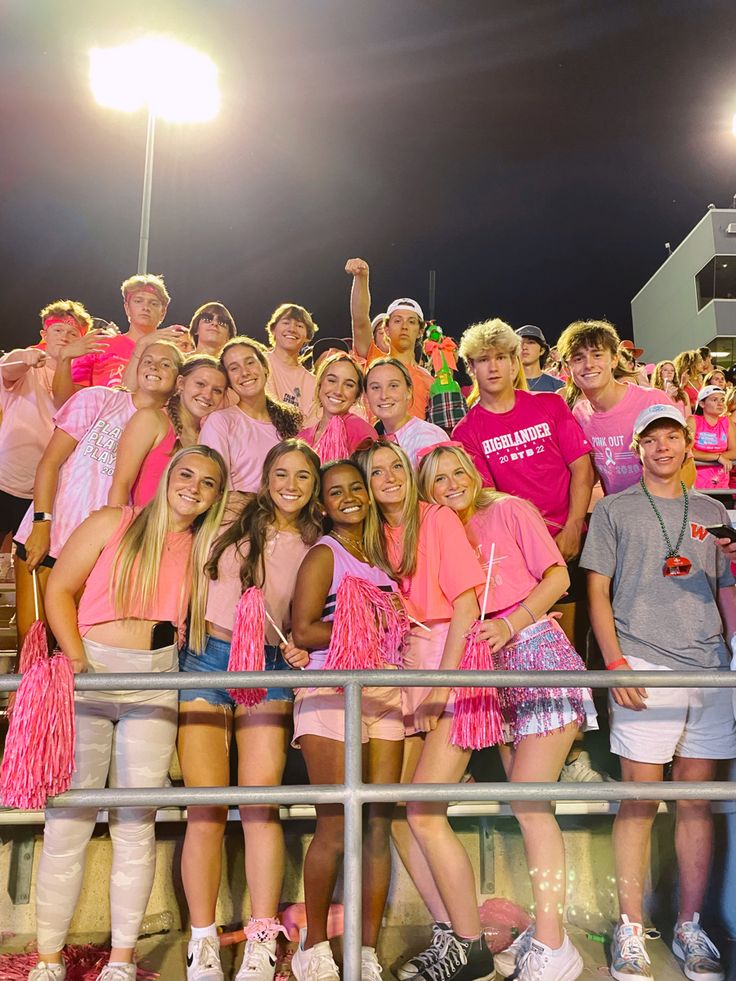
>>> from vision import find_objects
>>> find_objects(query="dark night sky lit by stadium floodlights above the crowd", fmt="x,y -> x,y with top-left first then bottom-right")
0,0 -> 736,354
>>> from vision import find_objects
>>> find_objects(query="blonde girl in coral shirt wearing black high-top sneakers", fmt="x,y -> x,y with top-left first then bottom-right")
356,440 -> 494,981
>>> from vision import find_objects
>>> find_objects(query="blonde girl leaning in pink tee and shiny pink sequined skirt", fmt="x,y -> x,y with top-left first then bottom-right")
418,443 -> 597,981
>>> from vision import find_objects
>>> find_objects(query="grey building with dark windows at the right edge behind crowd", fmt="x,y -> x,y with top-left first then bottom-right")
631,208 -> 736,365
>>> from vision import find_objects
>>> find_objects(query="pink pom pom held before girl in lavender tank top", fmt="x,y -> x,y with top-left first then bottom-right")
324,576 -> 409,671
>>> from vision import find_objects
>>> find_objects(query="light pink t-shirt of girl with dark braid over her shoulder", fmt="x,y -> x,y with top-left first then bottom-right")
199,405 -> 281,493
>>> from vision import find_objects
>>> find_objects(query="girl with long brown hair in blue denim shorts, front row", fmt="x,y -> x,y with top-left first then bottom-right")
179,439 -> 322,981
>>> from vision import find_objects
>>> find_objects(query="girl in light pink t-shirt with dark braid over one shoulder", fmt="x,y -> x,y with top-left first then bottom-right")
202,337 -> 302,506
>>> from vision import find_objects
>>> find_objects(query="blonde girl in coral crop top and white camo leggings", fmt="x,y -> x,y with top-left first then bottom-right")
29,446 -> 227,981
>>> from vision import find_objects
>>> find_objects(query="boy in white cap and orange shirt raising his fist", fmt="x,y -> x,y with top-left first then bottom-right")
345,259 -> 433,419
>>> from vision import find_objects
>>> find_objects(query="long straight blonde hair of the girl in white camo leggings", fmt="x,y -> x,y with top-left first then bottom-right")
110,446 -> 227,651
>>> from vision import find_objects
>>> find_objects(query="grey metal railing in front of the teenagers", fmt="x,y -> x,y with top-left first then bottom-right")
0,670 -> 736,979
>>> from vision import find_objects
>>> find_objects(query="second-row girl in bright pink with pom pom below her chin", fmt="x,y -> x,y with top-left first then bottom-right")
299,352 -> 377,463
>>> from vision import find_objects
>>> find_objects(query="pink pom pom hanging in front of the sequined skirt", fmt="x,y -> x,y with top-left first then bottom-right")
451,621 -> 503,749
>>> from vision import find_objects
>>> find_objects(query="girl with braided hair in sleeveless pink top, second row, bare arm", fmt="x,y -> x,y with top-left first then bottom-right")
107,354 -> 227,507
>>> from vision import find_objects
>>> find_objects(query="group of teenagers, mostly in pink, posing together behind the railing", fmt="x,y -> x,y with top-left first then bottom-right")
0,259 -> 736,981
